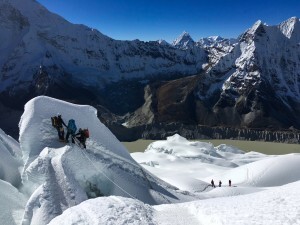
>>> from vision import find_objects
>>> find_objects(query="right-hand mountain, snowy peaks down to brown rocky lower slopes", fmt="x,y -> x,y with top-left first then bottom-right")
126,17 -> 300,132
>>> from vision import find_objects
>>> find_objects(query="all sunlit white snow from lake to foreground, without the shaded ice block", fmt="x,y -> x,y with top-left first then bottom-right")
50,135 -> 300,225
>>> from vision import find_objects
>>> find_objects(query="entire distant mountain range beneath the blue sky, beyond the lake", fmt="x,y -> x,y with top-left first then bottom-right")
0,0 -> 300,141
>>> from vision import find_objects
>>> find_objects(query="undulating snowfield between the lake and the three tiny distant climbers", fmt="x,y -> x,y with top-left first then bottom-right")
131,135 -> 300,191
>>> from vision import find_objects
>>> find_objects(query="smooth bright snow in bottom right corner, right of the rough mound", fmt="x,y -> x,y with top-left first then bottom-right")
154,182 -> 300,225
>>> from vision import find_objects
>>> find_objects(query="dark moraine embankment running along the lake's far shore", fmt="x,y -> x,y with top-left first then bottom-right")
107,123 -> 300,144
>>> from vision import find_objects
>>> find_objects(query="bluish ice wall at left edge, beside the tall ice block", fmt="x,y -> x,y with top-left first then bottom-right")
0,129 -> 23,187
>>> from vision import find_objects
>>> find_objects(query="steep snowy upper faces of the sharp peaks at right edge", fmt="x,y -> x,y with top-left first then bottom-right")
217,18 -> 300,101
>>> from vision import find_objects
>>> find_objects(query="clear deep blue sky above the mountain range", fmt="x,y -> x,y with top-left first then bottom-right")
38,0 -> 300,42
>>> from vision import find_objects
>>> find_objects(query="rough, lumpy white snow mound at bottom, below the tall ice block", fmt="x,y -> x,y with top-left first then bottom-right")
49,196 -> 155,225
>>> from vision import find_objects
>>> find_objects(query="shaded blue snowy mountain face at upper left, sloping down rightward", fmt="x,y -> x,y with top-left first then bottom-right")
0,0 -> 205,94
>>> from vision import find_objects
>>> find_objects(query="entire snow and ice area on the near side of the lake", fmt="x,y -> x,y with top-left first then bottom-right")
0,96 -> 300,225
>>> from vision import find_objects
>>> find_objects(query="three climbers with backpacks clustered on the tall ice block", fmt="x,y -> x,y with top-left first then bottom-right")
51,114 -> 89,148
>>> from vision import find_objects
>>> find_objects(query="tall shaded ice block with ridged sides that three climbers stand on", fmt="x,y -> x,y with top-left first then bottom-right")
20,96 -> 194,225
